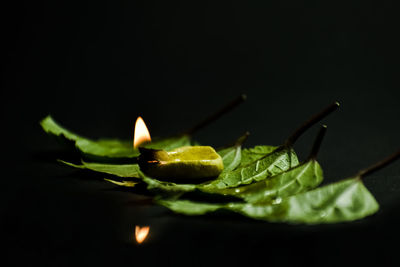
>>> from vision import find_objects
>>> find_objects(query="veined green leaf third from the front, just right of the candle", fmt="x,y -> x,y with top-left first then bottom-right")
200,146 -> 299,193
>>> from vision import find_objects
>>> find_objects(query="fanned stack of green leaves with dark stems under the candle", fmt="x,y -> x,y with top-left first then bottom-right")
41,103 -> 400,224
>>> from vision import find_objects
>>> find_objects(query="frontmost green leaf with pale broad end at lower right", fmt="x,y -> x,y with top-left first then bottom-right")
158,177 -> 379,224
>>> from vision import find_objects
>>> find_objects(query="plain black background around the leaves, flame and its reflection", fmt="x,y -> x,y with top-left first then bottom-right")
0,1 -> 400,266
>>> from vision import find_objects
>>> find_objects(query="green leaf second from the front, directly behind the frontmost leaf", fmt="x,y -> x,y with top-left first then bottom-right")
219,159 -> 323,203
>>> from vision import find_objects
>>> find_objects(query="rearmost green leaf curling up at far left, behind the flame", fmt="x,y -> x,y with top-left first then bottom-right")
40,116 -> 191,161
